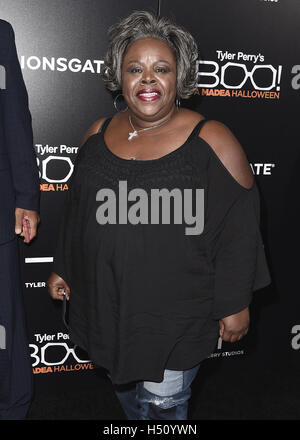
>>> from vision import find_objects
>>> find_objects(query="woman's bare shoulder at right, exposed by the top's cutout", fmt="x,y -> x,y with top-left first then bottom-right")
199,120 -> 254,189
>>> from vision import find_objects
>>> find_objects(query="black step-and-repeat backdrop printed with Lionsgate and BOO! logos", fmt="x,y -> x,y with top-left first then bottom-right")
0,0 -> 300,389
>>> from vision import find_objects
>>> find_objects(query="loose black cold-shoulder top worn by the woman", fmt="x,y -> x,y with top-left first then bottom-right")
53,117 -> 271,384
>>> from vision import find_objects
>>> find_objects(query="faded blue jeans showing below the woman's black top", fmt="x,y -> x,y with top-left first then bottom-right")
109,363 -> 200,420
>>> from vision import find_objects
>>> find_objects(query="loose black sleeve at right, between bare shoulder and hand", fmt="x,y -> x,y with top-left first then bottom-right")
213,183 -> 271,319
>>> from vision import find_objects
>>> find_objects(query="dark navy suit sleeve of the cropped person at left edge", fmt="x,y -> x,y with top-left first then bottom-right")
3,24 -> 40,211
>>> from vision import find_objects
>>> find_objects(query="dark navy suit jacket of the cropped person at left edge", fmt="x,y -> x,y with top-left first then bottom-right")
0,20 -> 40,244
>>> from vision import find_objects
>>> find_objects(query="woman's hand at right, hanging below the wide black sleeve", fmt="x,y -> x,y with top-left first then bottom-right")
219,307 -> 250,342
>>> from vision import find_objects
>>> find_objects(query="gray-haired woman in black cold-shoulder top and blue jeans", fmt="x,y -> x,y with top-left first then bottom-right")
48,11 -> 270,420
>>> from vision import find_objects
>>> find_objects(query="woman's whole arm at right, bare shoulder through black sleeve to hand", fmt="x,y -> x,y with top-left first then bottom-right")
201,121 -> 271,342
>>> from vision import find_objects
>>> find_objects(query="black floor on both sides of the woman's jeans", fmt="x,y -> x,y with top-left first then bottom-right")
28,361 -> 300,420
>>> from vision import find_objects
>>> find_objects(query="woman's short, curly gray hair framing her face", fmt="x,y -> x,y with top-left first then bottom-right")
100,11 -> 198,99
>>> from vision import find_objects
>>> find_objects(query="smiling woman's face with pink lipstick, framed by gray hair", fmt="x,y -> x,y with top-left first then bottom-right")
122,38 -> 176,121
